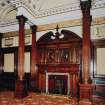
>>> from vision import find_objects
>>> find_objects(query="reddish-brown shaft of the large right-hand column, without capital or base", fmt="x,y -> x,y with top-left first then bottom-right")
82,8 -> 91,83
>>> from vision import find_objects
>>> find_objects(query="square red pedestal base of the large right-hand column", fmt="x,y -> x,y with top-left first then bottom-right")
79,84 -> 93,105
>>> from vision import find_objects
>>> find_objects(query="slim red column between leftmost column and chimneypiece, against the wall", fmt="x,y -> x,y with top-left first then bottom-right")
30,25 -> 38,91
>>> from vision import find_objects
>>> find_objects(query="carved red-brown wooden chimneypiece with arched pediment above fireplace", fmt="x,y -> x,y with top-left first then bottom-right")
37,28 -> 82,96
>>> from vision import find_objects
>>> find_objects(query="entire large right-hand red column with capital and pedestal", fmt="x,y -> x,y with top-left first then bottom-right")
79,0 -> 92,105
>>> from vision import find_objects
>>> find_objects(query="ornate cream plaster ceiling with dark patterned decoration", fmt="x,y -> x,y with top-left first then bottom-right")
0,0 -> 105,32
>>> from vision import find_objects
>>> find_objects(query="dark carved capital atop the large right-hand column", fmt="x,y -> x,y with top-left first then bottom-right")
80,0 -> 91,13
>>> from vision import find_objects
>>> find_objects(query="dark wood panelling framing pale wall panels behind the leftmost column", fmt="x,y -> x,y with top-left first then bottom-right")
0,46 -> 30,90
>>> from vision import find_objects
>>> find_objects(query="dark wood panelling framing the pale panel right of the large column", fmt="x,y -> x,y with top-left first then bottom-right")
92,39 -> 105,99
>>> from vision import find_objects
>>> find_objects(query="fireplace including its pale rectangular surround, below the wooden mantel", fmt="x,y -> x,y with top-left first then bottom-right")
46,73 -> 70,94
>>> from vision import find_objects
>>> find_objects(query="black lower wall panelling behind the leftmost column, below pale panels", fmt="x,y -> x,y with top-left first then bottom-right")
0,72 -> 30,91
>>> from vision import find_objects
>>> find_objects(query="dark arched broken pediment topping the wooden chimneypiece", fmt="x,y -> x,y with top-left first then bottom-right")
37,30 -> 82,45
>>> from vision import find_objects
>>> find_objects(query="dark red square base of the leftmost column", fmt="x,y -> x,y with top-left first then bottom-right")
14,80 -> 28,98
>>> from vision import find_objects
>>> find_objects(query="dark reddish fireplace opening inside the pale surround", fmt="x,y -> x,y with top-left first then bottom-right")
49,75 -> 67,94
